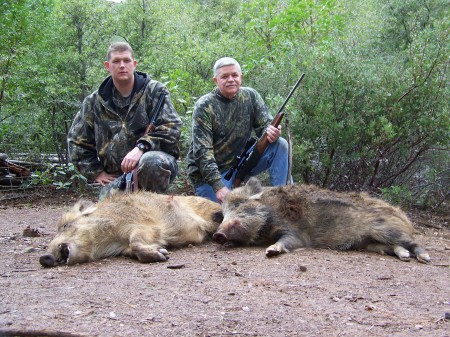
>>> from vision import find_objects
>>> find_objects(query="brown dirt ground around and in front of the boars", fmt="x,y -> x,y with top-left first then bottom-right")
0,186 -> 450,337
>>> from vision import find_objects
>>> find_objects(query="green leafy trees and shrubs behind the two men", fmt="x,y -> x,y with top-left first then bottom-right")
0,0 -> 450,208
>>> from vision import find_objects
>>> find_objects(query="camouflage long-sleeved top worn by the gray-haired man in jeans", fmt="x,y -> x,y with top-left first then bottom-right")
187,87 -> 272,191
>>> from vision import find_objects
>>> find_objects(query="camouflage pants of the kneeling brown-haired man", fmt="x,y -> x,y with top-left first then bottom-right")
99,151 -> 178,200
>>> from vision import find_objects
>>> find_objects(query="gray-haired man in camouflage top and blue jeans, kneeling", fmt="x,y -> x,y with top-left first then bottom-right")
187,57 -> 288,203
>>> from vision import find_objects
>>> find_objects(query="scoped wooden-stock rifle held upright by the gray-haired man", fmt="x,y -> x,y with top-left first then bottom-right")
225,74 -> 305,187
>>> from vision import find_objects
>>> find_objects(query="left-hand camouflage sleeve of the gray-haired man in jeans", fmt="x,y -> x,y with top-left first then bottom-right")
192,98 -> 225,191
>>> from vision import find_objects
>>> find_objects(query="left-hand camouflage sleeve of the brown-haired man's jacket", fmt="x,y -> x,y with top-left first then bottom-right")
67,94 -> 103,181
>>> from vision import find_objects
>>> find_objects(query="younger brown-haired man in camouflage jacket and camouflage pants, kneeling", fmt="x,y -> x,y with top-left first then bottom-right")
67,42 -> 181,199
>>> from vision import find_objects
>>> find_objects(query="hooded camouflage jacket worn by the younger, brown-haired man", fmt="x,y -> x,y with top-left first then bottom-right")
67,72 -> 181,181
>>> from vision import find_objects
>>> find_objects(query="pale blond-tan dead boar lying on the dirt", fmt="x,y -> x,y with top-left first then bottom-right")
39,192 -> 223,267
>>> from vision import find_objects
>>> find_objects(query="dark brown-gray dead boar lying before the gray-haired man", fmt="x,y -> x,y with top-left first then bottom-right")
213,178 -> 430,263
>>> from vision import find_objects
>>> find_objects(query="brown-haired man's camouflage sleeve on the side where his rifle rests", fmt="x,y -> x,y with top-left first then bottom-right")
139,81 -> 182,158
